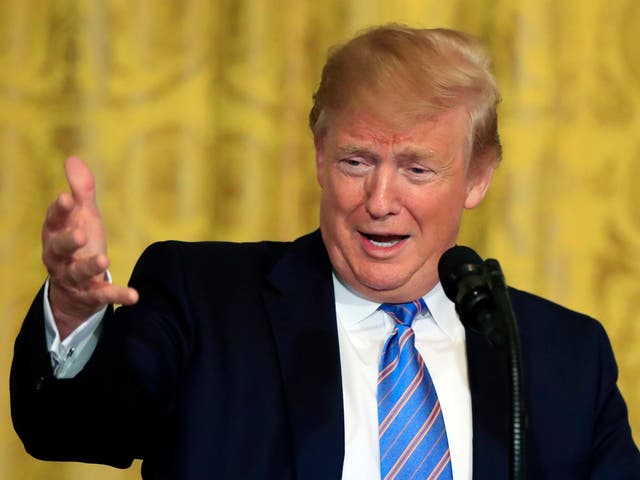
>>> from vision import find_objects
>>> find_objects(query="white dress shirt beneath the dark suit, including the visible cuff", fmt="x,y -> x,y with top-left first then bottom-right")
43,275 -> 472,480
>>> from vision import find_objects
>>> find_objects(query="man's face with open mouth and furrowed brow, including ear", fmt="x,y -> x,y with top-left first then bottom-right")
316,107 -> 493,302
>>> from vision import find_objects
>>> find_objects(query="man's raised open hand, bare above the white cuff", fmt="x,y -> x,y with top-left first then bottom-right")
42,157 -> 138,339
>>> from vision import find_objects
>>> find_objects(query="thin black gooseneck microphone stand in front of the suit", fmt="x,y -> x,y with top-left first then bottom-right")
483,258 -> 527,480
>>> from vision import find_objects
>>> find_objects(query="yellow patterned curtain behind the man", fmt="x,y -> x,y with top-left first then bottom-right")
0,0 -> 640,480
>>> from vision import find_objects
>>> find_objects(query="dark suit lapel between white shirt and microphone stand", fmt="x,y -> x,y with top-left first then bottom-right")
466,330 -> 510,480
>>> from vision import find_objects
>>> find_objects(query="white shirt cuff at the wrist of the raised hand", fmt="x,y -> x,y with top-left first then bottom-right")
43,278 -> 111,378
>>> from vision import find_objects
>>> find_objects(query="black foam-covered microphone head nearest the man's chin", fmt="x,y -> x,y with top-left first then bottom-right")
438,246 -> 505,348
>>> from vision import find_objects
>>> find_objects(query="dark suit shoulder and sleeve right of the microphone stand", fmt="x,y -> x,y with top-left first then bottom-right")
510,289 -> 639,478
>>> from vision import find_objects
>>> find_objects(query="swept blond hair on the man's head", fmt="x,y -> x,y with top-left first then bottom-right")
309,24 -> 502,169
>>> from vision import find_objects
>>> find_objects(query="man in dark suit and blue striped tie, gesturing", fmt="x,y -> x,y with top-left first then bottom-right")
11,26 -> 640,480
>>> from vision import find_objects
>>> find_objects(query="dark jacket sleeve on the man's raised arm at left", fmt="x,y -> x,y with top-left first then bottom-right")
10,243 -> 192,468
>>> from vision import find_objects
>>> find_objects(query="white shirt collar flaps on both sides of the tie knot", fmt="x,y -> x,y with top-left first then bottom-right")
332,272 -> 464,340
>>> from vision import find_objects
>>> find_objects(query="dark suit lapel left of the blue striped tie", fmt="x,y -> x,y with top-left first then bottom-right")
264,231 -> 344,480
